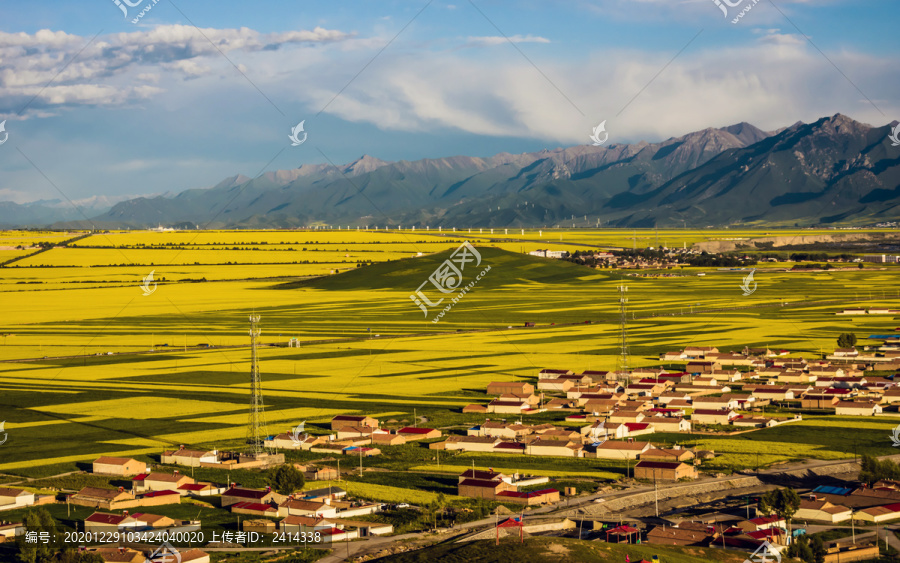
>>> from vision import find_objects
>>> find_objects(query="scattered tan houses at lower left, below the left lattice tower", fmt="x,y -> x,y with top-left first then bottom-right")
0,450 -> 393,563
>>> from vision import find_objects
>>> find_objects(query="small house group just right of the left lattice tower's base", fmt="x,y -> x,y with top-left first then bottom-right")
265,415 -> 442,457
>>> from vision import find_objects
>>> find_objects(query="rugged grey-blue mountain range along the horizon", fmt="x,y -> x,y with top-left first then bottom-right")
7,114 -> 900,228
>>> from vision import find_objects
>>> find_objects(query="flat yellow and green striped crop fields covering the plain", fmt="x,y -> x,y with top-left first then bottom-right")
0,227 -> 900,495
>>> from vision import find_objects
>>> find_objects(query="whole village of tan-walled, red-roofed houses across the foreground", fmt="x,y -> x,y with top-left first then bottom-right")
0,330 -> 900,563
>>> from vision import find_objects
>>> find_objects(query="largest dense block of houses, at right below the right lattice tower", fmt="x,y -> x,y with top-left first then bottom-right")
460,342 -> 900,442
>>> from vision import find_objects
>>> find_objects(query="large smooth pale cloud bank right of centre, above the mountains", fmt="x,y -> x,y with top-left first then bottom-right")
305,34 -> 898,145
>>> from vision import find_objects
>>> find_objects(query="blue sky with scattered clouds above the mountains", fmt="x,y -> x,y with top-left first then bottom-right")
0,0 -> 900,202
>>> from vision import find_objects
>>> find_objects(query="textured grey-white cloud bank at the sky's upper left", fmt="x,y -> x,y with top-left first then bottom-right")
0,24 -> 355,117
